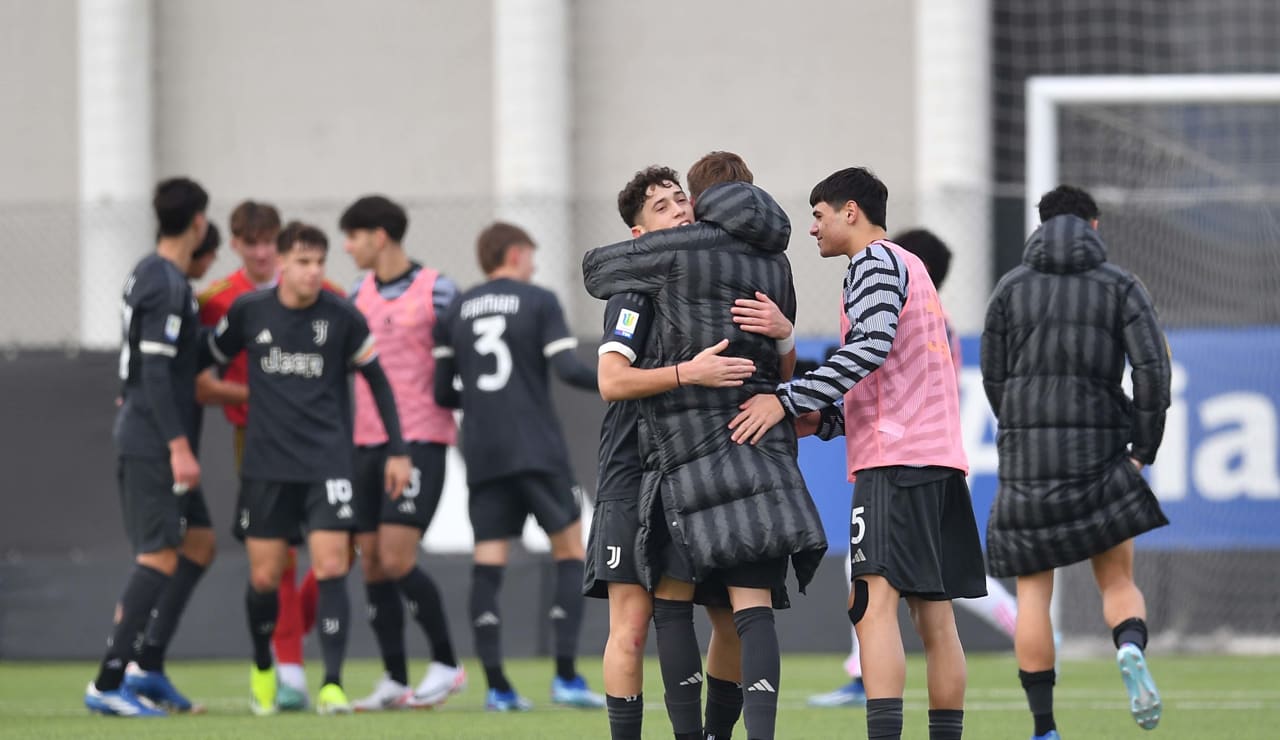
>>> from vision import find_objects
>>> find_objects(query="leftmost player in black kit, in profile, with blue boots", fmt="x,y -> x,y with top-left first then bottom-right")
84,178 -> 211,717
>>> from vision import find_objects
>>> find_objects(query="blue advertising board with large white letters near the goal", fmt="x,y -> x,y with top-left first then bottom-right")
797,326 -> 1280,554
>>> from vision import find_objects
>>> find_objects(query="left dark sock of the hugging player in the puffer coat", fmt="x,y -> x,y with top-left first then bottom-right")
653,599 -> 703,737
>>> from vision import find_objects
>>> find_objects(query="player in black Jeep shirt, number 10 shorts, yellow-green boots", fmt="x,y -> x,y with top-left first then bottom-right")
210,223 -> 412,714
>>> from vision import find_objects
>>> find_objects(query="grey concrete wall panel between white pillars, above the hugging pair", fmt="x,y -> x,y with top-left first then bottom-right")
572,0 -> 915,335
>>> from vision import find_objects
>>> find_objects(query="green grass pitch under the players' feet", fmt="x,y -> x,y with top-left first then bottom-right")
0,654 -> 1280,740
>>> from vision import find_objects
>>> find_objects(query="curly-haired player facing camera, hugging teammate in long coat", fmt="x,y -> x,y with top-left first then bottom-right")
585,160 -> 791,740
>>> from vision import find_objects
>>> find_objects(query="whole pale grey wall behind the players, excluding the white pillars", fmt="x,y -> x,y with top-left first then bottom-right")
0,0 -> 916,344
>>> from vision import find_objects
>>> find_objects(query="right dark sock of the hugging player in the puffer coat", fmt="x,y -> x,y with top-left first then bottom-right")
733,607 -> 782,740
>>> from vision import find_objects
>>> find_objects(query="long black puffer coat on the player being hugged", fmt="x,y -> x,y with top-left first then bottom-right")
582,183 -> 827,591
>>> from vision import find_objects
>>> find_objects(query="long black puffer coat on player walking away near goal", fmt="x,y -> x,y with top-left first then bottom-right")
982,215 -> 1170,576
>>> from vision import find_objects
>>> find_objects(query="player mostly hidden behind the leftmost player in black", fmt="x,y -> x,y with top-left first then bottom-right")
124,223 -> 232,713
